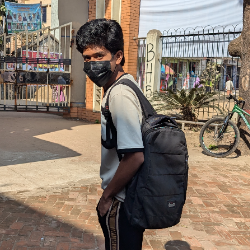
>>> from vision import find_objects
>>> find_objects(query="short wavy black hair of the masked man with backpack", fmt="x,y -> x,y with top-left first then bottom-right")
76,18 -> 125,66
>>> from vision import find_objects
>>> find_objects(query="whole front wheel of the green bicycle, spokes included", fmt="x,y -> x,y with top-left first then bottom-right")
199,118 -> 240,158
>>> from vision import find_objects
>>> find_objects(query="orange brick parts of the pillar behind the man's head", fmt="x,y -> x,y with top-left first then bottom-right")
65,0 -> 140,122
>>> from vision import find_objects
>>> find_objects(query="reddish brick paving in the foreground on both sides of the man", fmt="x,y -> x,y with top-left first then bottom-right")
0,163 -> 250,250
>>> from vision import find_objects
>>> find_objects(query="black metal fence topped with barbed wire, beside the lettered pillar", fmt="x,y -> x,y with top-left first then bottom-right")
137,26 -> 241,120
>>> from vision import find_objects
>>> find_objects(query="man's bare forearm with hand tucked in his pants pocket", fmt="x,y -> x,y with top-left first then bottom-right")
98,152 -> 144,216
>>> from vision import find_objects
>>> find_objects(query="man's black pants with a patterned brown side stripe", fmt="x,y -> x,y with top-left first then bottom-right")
97,199 -> 144,250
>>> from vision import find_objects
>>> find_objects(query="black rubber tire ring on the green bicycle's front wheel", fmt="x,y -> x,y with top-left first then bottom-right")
199,118 -> 240,158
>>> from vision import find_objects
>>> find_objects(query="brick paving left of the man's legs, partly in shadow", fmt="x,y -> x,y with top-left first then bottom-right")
0,186 -> 104,250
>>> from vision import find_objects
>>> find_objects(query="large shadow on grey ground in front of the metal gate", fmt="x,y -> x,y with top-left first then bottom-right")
0,112 -> 97,166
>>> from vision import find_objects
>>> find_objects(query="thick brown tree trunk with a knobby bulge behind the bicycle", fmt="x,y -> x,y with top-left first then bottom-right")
228,0 -> 250,155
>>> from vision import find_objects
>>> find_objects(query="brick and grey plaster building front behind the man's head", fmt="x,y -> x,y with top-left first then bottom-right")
14,0 -> 140,122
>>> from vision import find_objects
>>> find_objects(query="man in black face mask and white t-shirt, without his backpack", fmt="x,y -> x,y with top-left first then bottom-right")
76,19 -> 144,250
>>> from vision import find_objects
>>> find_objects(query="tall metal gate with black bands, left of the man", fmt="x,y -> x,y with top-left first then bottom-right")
0,23 -> 72,112
